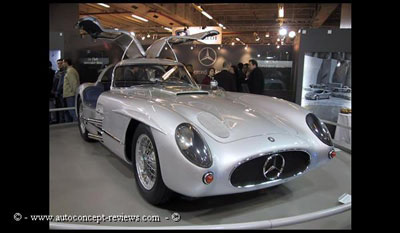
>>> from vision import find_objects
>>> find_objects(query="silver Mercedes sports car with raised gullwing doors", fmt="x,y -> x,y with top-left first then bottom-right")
76,17 -> 336,205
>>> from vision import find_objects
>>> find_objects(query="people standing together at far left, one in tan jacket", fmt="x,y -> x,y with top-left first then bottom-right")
49,58 -> 80,124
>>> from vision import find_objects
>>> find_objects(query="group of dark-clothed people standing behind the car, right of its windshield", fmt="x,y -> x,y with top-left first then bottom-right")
190,59 -> 264,94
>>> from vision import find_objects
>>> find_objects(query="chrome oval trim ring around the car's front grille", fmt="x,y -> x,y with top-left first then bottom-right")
229,149 -> 311,189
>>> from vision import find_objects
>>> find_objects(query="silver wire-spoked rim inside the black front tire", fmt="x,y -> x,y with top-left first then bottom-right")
135,134 -> 157,190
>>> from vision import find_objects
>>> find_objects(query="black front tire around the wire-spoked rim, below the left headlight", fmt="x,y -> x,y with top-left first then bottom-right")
131,124 -> 173,205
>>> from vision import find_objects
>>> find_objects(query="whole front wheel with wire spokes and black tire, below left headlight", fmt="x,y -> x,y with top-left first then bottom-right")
131,124 -> 172,205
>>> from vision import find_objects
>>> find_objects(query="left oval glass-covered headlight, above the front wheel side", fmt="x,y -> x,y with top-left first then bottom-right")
175,123 -> 212,168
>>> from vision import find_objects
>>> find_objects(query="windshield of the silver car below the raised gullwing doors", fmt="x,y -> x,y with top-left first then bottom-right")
114,64 -> 198,87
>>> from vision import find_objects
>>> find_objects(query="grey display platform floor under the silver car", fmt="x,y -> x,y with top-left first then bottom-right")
49,124 -> 351,229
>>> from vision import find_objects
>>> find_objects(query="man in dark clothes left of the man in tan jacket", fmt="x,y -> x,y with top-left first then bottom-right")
52,59 -> 65,123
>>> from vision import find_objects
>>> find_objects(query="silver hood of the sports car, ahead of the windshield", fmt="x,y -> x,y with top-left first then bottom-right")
126,86 -> 296,143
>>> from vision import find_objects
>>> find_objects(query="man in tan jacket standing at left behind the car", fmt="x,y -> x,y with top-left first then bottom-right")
63,58 -> 80,121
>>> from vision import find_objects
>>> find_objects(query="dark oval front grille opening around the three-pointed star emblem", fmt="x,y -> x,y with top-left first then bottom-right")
231,151 -> 310,187
